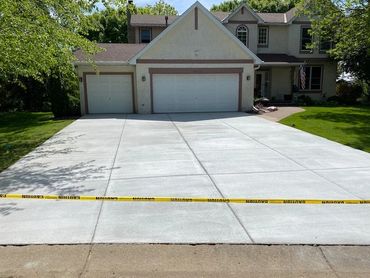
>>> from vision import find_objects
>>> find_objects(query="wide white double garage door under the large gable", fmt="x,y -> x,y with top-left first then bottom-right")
153,74 -> 239,113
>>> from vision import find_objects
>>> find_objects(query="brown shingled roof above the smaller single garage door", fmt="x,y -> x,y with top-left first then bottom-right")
74,43 -> 146,64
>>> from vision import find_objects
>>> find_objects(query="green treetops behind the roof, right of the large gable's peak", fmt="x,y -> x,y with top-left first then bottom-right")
211,0 -> 299,13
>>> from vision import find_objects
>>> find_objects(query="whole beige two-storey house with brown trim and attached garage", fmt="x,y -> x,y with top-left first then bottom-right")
75,2 -> 336,114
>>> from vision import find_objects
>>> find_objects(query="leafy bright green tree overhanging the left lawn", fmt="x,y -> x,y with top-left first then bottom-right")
0,0 -> 98,81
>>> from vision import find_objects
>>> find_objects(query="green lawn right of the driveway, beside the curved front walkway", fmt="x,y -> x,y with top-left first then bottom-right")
280,106 -> 370,152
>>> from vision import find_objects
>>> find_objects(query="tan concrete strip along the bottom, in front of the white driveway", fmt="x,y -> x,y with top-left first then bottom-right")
0,244 -> 370,277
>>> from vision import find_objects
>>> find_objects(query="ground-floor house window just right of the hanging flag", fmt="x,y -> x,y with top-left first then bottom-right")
298,66 -> 322,91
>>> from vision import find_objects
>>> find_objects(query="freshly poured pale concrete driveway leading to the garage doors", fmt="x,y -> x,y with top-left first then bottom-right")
0,113 -> 370,244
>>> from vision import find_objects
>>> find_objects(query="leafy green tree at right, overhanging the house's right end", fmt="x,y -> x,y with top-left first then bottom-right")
299,0 -> 370,84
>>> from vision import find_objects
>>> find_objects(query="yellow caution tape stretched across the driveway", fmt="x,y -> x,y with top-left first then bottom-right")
0,194 -> 370,205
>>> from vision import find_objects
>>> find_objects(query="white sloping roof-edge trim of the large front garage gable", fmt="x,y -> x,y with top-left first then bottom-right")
129,1 -> 263,64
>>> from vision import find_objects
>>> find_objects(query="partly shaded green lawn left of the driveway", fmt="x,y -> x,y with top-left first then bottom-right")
0,112 -> 73,172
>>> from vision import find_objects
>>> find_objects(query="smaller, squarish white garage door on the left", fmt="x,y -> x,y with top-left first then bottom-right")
86,74 -> 133,114
